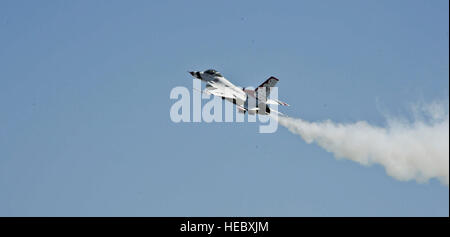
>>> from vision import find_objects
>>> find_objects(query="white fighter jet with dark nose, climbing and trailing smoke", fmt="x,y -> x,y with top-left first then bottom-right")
189,69 -> 289,115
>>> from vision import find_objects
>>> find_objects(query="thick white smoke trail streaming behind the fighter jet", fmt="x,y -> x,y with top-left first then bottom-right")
278,102 -> 449,186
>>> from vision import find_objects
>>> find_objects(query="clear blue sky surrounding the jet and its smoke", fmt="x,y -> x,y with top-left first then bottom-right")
0,0 -> 449,216
